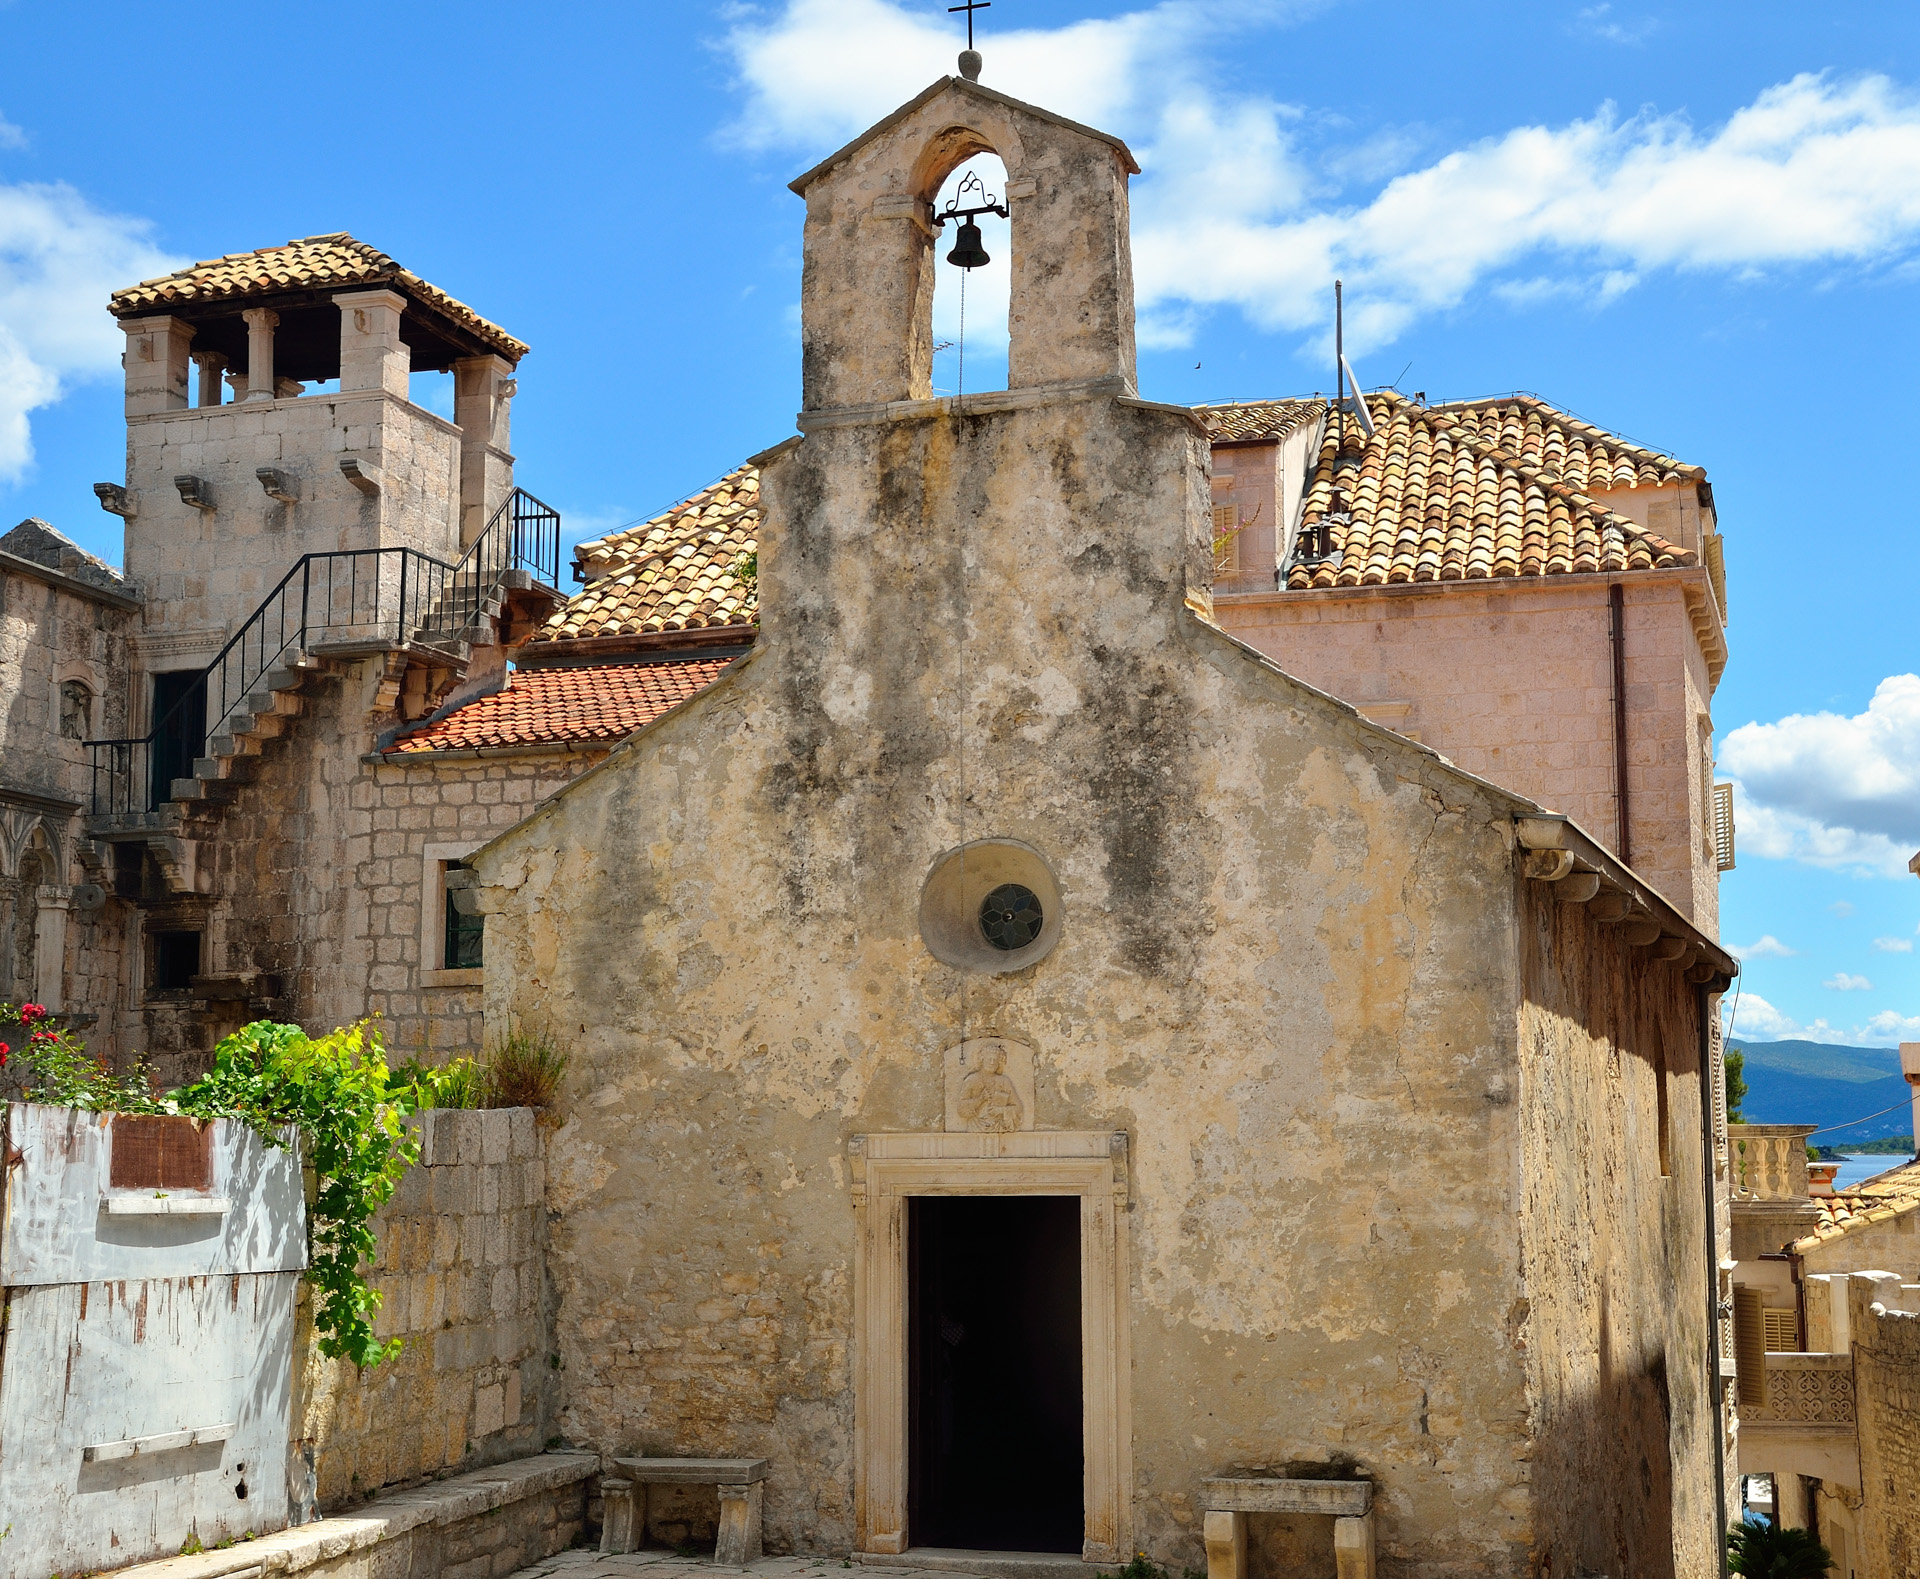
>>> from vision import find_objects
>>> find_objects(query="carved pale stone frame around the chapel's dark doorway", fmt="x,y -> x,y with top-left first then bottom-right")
847,1130 -> 1133,1564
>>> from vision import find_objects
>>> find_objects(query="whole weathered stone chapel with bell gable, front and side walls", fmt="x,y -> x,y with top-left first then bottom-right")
472,79 -> 1736,1575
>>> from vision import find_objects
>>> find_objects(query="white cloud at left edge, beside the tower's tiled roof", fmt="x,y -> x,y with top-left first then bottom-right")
0,184 -> 182,482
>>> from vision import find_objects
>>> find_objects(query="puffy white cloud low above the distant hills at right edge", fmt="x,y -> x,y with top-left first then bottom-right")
1718,674 -> 1920,878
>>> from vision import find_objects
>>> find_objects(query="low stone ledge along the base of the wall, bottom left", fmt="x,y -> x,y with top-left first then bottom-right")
113,1452 -> 599,1579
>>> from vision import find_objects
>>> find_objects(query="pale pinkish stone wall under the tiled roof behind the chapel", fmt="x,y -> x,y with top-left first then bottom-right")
1213,571 -> 1720,935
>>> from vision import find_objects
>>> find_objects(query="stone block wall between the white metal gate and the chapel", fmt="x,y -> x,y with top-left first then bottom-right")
294,1108 -> 559,1512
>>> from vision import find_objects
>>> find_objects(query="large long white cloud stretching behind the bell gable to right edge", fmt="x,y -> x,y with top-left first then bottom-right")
724,0 -> 1920,352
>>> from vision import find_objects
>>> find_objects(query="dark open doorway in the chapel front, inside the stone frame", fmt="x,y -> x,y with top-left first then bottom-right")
906,1195 -> 1085,1554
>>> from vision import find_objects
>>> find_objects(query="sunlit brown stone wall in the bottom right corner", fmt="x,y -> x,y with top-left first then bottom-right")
1849,1277 -> 1920,1579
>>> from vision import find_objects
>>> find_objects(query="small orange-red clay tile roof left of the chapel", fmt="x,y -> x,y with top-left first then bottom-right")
386,657 -> 733,755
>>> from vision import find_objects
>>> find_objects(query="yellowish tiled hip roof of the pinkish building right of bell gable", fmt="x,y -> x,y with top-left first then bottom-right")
1286,390 -> 1705,592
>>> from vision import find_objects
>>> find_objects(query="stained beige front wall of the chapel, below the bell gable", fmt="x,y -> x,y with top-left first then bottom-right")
478,380 -> 1711,1573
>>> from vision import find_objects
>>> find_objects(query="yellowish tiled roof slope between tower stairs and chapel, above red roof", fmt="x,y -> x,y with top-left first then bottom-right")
534,465 -> 760,642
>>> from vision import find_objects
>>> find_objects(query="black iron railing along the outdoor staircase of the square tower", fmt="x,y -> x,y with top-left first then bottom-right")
86,488 -> 561,816
